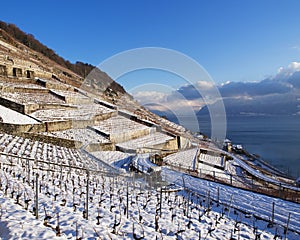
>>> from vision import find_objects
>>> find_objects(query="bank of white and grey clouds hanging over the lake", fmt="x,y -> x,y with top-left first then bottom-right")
133,62 -> 300,115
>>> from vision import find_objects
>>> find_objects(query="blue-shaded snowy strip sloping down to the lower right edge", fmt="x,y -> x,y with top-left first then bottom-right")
162,167 -> 300,234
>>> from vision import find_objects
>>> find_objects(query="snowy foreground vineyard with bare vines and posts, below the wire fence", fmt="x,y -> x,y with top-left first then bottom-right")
0,150 -> 300,240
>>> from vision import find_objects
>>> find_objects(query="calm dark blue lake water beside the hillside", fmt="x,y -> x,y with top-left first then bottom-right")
170,116 -> 300,177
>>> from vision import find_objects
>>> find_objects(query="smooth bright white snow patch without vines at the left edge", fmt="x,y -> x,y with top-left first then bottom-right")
0,105 -> 38,124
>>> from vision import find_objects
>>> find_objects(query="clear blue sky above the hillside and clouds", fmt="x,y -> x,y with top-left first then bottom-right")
0,0 -> 300,87
